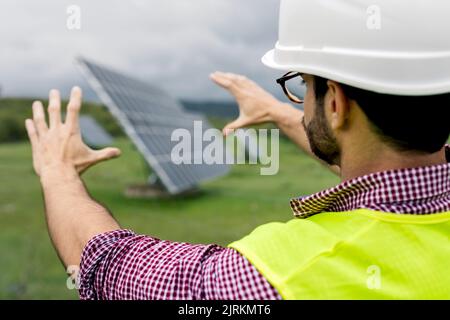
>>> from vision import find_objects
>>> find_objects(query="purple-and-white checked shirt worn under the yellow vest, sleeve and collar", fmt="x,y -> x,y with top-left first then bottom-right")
79,146 -> 450,300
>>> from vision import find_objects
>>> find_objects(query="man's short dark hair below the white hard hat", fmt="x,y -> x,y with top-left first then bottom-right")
314,76 -> 450,153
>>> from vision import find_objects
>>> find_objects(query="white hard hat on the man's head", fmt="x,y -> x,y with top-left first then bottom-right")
262,0 -> 450,96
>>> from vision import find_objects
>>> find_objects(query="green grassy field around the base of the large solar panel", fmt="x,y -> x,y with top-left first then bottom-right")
0,140 -> 338,299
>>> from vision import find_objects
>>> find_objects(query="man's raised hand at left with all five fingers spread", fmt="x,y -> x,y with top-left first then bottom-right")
25,87 -> 120,175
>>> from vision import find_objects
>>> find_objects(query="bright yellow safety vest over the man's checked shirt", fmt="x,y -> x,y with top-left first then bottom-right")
229,209 -> 450,299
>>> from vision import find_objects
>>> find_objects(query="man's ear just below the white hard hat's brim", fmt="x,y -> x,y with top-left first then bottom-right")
327,80 -> 350,130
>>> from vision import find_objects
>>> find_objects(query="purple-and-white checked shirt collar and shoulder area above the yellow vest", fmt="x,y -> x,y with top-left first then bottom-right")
290,145 -> 450,218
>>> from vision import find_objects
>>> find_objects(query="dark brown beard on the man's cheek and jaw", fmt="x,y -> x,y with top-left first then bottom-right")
302,103 -> 341,165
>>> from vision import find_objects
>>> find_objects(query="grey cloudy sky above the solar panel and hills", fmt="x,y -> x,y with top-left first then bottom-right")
0,0 -> 280,100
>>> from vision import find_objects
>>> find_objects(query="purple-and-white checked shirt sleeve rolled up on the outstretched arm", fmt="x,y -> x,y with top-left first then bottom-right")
78,230 -> 281,300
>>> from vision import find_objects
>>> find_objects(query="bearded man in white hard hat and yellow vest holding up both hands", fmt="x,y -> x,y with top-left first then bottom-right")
26,0 -> 450,299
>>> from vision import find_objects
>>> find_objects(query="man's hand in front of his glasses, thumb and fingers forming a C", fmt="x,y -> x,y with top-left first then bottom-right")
211,72 -> 282,135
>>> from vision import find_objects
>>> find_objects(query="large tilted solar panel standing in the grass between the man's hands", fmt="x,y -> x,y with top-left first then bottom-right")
78,58 -> 229,194
